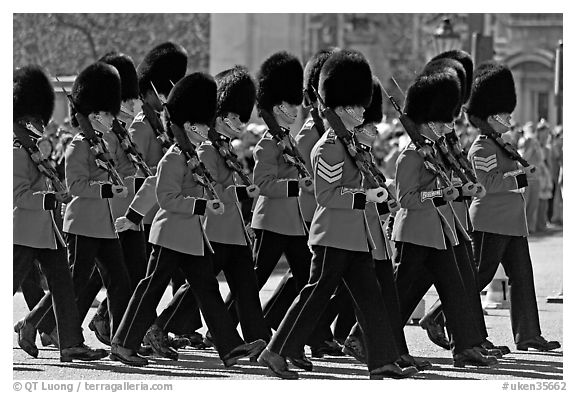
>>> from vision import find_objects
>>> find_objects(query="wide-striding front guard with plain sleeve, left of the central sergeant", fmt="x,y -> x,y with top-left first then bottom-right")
110,72 -> 266,367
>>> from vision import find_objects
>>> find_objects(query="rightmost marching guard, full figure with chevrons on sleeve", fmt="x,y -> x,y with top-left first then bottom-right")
466,62 -> 560,351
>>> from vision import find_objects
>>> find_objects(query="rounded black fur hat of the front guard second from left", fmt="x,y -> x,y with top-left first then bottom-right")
72,61 -> 122,116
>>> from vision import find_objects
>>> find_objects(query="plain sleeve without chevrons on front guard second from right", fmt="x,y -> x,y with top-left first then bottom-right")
395,150 -> 446,210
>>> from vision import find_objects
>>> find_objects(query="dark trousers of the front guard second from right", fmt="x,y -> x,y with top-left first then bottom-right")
394,239 -> 483,354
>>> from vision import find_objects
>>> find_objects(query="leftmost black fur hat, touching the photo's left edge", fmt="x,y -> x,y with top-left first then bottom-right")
12,65 -> 54,125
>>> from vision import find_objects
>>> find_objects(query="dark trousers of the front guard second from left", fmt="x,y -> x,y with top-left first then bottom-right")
38,233 -> 132,334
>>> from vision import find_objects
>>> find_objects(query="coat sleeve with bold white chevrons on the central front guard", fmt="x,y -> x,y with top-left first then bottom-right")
312,144 -> 366,210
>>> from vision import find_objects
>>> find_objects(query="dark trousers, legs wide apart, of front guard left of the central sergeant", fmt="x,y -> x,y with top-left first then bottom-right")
112,246 -> 243,358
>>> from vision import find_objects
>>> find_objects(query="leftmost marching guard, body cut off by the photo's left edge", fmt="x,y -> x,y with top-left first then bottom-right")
12,66 -> 108,362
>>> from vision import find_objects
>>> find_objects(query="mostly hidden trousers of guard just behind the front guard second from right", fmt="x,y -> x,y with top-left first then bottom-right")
427,231 -> 488,339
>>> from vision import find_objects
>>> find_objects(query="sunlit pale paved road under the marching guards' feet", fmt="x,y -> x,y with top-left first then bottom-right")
13,231 -> 563,380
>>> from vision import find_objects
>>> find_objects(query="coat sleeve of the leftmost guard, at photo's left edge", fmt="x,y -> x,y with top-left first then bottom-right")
12,148 -> 56,210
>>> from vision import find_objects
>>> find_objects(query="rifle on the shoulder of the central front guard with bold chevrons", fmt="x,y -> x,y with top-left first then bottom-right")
312,87 -> 400,213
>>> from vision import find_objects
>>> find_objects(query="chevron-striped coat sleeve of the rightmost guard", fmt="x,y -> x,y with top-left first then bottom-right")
468,144 -> 528,194
